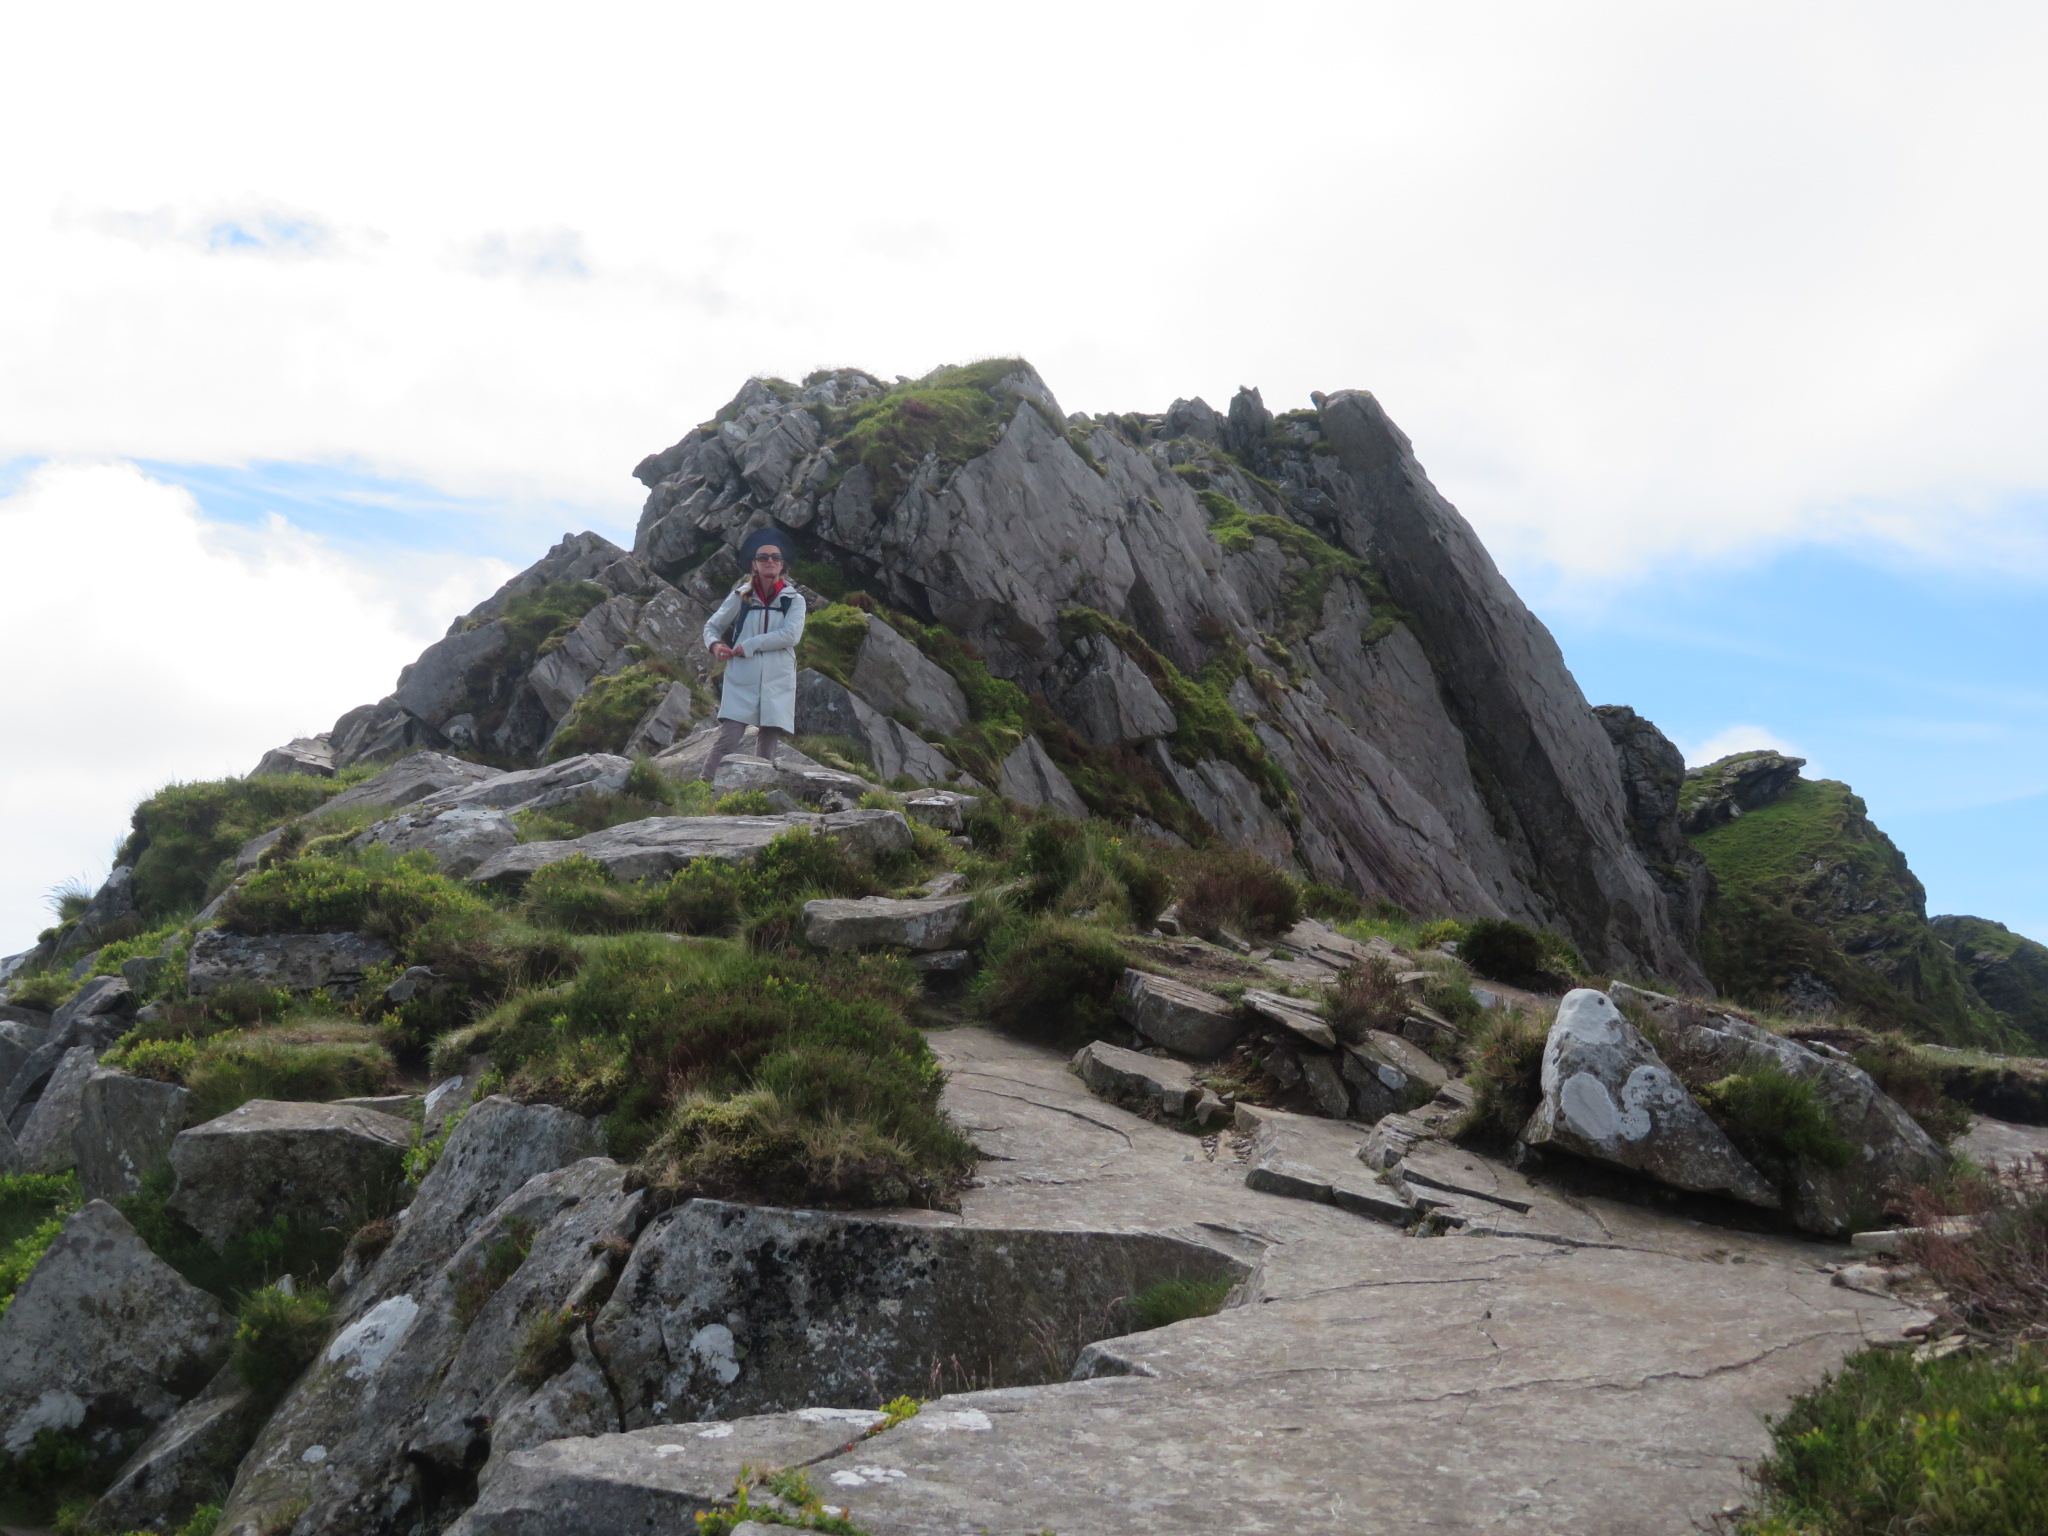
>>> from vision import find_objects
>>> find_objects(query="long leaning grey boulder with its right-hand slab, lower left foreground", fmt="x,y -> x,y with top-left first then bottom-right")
219,1098 -> 610,1536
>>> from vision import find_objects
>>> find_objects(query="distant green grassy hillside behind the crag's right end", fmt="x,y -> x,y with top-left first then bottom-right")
1694,778 -> 2005,1044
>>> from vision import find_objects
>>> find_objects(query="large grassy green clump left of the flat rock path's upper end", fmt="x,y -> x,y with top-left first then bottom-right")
464,934 -> 973,1204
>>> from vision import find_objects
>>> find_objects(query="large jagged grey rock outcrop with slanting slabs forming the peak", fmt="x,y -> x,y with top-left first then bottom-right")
635,365 -> 1702,985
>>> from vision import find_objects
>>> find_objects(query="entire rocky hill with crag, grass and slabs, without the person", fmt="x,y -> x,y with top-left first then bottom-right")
0,358 -> 2048,1536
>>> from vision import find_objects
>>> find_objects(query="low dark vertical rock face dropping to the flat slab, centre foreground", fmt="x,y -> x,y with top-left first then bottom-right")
592,1200 -> 1245,1427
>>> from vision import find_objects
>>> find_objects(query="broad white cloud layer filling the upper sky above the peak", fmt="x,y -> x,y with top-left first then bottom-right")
0,0 -> 2048,580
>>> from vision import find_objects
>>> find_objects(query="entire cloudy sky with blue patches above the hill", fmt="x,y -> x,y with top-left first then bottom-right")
0,0 -> 2048,954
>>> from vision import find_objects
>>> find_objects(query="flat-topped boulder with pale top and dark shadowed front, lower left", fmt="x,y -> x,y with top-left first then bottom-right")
170,1098 -> 412,1249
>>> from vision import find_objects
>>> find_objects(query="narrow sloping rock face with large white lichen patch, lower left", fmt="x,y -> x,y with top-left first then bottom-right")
219,1098 -> 602,1536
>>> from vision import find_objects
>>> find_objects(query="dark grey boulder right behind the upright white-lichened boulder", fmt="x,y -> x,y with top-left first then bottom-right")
1614,983 -> 1950,1237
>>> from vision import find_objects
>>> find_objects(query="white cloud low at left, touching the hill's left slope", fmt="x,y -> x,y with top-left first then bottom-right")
0,463 -> 510,952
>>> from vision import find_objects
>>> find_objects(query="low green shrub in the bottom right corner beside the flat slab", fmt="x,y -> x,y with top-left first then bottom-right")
1737,1348 -> 2048,1536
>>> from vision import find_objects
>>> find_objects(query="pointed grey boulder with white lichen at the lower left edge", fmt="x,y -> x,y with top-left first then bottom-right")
0,1200 -> 233,1475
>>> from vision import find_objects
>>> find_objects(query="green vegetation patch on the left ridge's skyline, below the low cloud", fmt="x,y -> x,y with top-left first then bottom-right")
117,770 -> 354,922
